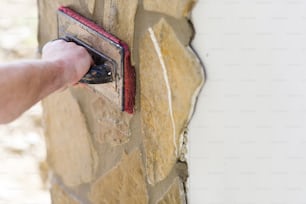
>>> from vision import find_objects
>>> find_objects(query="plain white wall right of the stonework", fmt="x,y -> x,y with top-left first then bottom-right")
189,0 -> 306,204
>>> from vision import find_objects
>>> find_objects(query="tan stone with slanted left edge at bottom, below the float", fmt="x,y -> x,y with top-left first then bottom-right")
89,150 -> 148,204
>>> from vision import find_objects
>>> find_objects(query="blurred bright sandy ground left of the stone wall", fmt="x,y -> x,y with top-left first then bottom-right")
0,0 -> 51,204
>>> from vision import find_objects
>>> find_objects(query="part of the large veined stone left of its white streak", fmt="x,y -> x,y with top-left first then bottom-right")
140,29 -> 176,184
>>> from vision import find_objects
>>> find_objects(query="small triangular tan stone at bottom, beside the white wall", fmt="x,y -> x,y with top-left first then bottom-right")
158,178 -> 186,204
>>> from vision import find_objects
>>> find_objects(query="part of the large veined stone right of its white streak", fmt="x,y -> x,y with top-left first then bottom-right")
153,19 -> 204,146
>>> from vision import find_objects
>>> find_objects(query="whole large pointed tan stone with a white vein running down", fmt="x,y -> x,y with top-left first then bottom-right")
139,19 -> 203,184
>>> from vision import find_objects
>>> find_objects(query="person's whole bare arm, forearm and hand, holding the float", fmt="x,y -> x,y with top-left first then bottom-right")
0,40 -> 92,124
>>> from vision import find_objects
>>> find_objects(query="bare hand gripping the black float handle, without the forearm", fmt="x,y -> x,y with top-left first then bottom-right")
42,40 -> 93,85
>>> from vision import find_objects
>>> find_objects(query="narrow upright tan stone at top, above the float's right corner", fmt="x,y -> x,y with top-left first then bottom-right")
103,0 -> 138,49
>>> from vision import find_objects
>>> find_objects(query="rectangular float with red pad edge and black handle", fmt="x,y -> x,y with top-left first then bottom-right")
57,7 -> 136,113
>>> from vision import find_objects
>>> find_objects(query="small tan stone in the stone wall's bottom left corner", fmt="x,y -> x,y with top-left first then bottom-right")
51,184 -> 81,204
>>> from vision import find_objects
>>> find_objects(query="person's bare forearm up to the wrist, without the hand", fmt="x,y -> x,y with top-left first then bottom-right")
0,60 -> 66,124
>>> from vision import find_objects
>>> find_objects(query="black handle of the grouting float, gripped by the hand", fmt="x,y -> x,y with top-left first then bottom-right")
60,36 -> 116,84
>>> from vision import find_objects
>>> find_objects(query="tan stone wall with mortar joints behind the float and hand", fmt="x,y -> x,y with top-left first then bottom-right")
38,0 -> 204,204
